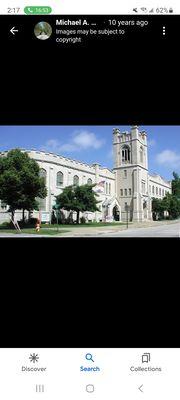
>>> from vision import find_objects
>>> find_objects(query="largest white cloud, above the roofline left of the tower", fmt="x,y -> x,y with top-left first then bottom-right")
42,130 -> 105,153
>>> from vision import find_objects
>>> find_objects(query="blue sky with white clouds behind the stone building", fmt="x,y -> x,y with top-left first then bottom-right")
0,125 -> 180,179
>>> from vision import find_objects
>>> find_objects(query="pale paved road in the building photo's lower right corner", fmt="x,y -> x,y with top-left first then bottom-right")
101,221 -> 180,238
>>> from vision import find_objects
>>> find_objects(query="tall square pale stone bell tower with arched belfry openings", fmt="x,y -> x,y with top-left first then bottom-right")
113,126 -> 152,221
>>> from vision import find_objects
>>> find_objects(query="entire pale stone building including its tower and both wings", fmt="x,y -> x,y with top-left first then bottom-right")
0,126 -> 171,223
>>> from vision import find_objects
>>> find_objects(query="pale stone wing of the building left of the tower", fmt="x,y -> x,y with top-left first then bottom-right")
0,149 -> 120,222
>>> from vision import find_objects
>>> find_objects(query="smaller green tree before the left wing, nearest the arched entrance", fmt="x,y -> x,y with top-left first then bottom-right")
55,185 -> 99,224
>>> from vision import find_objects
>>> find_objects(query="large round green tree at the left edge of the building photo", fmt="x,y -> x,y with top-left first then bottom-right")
0,149 -> 47,220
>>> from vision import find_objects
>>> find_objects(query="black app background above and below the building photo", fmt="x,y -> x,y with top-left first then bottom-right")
0,16 -> 180,347
